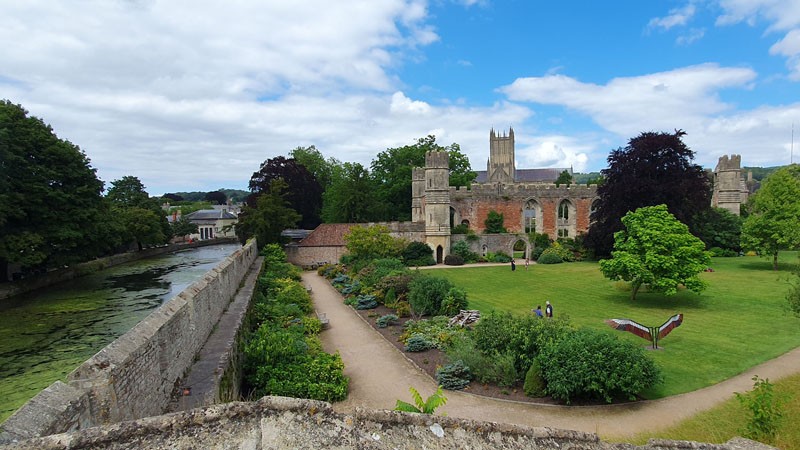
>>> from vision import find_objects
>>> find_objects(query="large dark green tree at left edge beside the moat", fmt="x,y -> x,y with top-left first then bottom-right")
0,100 -> 106,278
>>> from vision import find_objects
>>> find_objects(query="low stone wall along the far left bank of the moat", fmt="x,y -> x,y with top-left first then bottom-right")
0,239 -> 236,300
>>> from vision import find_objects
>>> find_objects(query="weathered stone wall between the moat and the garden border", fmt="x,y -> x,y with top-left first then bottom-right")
0,241 -> 258,442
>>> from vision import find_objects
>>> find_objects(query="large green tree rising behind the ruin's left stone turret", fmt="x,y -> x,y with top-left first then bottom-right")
371,136 -> 477,220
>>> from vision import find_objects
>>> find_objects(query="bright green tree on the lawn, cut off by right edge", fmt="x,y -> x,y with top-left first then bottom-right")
742,164 -> 800,270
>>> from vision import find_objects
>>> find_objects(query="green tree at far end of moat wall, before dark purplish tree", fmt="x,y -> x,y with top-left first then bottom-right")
236,178 -> 301,247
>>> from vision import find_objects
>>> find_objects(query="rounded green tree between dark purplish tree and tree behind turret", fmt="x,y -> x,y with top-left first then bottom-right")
322,162 -> 378,223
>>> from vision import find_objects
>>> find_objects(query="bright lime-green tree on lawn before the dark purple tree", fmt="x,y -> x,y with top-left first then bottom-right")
600,205 -> 711,300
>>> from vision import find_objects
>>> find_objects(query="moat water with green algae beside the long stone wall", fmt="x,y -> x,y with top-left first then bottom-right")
0,244 -> 241,422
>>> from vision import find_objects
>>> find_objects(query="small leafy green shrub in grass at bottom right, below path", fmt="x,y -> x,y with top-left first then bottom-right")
736,375 -> 786,443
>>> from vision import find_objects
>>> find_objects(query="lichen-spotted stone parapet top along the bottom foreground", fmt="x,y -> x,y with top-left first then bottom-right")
0,397 -> 770,450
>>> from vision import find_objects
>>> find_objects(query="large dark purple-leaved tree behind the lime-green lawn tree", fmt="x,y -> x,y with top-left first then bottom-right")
585,130 -> 711,256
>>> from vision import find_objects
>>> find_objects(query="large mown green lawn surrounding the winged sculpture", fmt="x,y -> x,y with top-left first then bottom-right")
431,252 -> 800,398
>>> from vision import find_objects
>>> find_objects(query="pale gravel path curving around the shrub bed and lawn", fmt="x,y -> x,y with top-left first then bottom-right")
303,272 -> 800,440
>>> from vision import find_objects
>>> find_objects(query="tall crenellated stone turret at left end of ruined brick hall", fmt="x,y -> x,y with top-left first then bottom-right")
424,152 -> 450,263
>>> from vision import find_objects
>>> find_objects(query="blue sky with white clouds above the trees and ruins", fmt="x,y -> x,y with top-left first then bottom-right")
0,0 -> 800,195
